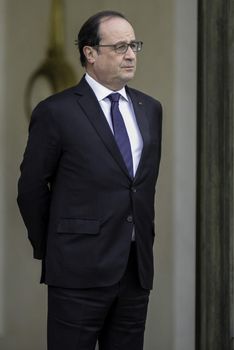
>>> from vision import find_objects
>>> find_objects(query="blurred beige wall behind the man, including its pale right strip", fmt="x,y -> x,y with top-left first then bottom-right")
0,0 -> 197,350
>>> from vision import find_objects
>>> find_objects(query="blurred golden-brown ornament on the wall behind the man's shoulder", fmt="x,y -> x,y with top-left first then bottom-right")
25,0 -> 77,118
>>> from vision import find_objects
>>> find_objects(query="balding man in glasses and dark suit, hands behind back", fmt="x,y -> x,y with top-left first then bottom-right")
18,11 -> 162,350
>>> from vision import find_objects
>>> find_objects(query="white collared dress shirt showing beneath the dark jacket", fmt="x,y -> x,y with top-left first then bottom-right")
85,73 -> 143,176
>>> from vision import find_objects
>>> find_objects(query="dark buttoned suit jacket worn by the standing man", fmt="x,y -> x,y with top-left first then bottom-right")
17,78 -> 162,289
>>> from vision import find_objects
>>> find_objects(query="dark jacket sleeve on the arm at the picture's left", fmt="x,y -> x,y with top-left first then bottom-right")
17,103 -> 61,259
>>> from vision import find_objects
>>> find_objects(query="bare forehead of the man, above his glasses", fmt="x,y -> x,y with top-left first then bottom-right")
99,17 -> 135,42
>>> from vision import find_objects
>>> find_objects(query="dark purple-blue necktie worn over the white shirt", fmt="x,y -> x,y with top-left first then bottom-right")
107,93 -> 133,178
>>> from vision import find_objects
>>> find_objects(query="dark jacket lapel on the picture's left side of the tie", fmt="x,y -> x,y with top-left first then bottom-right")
75,77 -> 130,178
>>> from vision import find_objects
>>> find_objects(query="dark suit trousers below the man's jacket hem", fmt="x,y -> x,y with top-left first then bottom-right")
48,243 -> 149,350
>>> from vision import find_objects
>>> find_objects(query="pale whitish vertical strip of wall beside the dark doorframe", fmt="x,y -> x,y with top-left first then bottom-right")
172,0 -> 197,350
